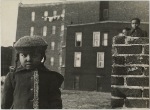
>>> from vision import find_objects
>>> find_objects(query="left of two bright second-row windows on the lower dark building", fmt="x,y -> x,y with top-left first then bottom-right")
74,52 -> 81,67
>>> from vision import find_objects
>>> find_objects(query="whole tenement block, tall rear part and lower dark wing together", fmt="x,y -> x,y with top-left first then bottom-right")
12,1 -> 149,91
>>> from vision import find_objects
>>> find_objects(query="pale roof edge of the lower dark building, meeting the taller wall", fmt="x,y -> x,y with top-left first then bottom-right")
67,21 -> 149,27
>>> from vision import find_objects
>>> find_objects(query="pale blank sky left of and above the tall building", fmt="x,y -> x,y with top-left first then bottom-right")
0,0 -> 65,47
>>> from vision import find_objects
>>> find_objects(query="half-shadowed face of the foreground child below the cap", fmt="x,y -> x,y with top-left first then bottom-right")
19,52 -> 42,69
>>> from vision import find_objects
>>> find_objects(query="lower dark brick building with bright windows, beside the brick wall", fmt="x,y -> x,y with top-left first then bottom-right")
64,21 -> 149,92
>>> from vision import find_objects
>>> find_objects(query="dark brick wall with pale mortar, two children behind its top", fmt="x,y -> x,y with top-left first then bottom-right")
111,36 -> 149,108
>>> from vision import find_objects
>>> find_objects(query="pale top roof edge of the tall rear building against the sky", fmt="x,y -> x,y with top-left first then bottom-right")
19,1 -> 88,7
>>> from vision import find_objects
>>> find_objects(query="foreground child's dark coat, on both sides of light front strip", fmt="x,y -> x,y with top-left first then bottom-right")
1,65 -> 64,109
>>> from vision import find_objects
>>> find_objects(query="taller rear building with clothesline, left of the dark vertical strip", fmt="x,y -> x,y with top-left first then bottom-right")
12,1 -> 99,74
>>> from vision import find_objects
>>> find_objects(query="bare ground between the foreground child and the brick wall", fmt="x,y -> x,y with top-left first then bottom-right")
62,90 -> 111,109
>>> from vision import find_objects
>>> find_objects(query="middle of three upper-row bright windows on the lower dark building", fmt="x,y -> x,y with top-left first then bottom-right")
93,32 -> 100,47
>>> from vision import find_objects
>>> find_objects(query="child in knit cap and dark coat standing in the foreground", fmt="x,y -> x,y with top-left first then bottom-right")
1,36 -> 64,109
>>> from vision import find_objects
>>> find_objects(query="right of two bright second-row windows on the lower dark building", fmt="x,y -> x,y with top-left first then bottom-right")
97,52 -> 104,68
